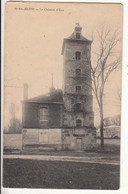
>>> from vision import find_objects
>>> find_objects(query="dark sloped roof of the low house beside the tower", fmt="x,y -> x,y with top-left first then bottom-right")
23,89 -> 63,104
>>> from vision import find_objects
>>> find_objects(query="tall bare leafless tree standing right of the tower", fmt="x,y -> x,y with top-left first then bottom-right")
90,28 -> 120,149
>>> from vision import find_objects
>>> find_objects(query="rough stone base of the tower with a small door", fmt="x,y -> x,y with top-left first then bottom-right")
62,127 -> 96,151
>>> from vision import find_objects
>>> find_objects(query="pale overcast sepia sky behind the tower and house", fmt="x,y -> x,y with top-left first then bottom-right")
4,2 -> 122,125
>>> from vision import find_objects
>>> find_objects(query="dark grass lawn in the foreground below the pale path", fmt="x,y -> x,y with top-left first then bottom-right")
3,159 -> 120,189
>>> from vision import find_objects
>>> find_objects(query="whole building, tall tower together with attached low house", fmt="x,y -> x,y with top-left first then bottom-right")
22,24 -> 96,150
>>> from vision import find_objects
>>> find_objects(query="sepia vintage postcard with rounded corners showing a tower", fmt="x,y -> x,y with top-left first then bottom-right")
3,2 -> 123,190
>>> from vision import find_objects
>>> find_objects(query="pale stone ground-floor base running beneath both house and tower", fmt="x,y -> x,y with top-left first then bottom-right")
22,127 -> 96,151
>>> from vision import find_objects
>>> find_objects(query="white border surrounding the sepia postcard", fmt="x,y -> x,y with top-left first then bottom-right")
1,0 -> 128,194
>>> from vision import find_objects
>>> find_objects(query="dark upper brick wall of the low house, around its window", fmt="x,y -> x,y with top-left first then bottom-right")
22,102 -> 63,128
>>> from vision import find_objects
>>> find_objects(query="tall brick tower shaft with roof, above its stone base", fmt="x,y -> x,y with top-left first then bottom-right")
62,23 -> 94,128
